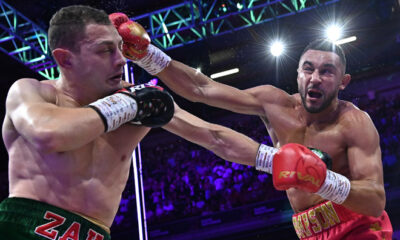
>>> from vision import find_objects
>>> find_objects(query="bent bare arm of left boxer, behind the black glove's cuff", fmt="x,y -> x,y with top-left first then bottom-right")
5,79 -> 104,152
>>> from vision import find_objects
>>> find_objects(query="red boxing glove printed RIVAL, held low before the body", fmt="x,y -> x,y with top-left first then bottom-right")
272,143 -> 327,193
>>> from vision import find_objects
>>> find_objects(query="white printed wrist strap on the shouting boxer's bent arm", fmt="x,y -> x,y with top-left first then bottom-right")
316,170 -> 351,204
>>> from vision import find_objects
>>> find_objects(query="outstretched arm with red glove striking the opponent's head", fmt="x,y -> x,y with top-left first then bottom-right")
109,13 -> 277,116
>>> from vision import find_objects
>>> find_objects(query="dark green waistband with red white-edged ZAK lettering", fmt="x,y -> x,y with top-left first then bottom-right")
0,198 -> 110,240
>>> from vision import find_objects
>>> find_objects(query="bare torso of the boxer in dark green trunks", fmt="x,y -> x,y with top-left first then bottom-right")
3,81 -> 149,227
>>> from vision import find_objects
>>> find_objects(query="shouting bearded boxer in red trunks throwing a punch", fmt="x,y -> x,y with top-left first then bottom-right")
113,13 -> 392,239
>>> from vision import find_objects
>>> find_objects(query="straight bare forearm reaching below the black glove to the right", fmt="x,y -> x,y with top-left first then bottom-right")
163,105 -> 259,166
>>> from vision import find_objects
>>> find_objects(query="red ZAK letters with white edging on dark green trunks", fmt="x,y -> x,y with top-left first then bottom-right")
35,211 -> 104,240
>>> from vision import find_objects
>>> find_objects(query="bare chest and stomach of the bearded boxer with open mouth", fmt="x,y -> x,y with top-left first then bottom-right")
262,102 -> 349,212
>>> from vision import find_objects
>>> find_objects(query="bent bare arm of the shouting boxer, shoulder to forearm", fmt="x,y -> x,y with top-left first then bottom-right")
343,111 -> 386,217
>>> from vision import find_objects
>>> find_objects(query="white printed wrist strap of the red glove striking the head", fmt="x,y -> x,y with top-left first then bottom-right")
132,44 -> 171,75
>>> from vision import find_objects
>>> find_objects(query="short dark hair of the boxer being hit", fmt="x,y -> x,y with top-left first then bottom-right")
48,5 -> 111,52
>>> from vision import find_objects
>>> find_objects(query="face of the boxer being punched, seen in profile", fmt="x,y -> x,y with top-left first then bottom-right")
70,24 -> 126,94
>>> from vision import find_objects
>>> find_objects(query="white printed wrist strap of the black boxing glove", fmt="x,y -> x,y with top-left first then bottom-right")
88,93 -> 137,132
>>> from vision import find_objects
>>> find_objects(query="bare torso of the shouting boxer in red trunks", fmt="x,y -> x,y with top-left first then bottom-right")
262,95 -> 357,212
